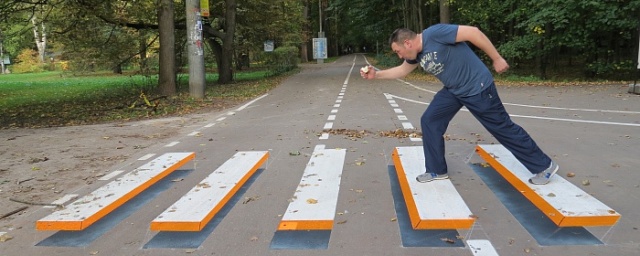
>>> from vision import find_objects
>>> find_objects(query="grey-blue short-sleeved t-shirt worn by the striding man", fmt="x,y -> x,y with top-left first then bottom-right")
406,24 -> 493,97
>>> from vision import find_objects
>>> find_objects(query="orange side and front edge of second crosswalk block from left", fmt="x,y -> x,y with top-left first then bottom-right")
150,152 -> 269,231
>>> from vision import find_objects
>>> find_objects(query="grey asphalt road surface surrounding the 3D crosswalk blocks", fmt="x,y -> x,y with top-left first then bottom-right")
0,55 -> 640,255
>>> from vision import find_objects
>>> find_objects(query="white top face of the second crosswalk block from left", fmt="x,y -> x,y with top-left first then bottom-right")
153,151 -> 268,226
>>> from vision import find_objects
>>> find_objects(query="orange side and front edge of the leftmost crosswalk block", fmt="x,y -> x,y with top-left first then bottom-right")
36,152 -> 196,230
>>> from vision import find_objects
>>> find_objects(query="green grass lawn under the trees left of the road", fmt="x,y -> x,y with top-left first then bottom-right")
0,71 -> 287,128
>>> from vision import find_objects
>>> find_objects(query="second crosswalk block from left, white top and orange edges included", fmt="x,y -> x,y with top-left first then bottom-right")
150,151 -> 269,231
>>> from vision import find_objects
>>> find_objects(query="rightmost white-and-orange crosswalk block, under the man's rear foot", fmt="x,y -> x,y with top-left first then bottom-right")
476,145 -> 620,227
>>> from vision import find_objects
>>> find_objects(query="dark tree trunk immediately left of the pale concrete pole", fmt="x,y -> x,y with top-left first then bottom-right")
158,0 -> 176,95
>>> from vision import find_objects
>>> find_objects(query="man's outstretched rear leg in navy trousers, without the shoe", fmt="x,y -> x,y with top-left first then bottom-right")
461,84 -> 551,174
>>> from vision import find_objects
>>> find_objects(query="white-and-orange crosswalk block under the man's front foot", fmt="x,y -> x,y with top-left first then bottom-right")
393,146 -> 475,229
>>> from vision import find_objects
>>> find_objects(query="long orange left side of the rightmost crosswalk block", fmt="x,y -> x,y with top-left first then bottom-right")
476,145 -> 565,225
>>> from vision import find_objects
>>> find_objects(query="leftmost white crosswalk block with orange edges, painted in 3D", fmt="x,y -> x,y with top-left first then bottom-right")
36,152 -> 195,230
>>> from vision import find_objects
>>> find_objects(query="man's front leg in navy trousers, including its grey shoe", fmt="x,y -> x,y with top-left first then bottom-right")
418,88 -> 462,182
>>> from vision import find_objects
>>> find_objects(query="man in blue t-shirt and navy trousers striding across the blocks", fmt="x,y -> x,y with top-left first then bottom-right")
360,24 -> 559,185
